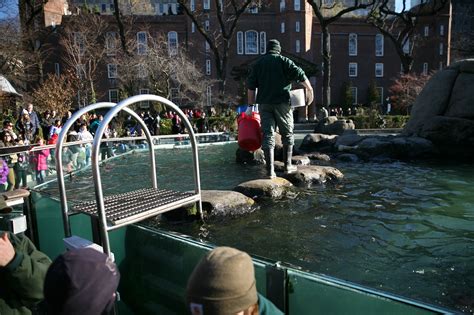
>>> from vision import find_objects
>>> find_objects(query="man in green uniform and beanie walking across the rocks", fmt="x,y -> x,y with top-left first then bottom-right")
247,39 -> 313,178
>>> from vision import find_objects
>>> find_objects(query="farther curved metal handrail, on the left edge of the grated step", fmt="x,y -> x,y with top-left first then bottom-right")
54,102 -> 144,237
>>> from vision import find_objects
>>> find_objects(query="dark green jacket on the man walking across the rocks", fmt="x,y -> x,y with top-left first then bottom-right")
247,53 -> 307,104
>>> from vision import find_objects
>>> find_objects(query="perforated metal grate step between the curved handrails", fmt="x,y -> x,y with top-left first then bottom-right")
72,188 -> 199,230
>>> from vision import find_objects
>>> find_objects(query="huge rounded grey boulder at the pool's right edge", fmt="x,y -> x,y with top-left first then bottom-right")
403,59 -> 474,161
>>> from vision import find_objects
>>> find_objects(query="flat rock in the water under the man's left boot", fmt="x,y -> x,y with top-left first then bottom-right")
234,177 -> 293,199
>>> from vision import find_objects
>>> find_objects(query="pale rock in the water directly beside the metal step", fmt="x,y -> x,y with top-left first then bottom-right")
201,190 -> 255,216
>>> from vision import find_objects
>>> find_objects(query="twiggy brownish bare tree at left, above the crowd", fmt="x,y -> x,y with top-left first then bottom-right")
60,13 -> 108,103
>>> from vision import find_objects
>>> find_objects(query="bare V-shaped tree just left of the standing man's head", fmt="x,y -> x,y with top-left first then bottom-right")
178,0 -> 260,99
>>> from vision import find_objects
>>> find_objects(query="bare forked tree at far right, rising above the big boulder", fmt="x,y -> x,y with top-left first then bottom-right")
367,0 -> 449,74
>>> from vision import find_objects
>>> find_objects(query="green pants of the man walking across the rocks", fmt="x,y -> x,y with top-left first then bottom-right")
258,103 -> 295,149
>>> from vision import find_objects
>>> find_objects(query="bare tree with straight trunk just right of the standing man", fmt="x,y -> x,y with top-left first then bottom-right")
307,0 -> 376,106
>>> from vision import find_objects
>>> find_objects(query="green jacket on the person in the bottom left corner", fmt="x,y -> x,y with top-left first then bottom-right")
0,231 -> 51,315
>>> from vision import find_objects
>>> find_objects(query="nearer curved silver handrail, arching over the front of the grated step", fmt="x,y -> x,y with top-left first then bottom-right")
91,94 -> 202,256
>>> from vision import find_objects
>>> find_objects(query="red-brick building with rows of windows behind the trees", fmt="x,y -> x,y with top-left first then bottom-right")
36,0 -> 451,118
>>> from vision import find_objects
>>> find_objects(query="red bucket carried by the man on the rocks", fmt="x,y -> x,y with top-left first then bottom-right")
237,112 -> 262,151
